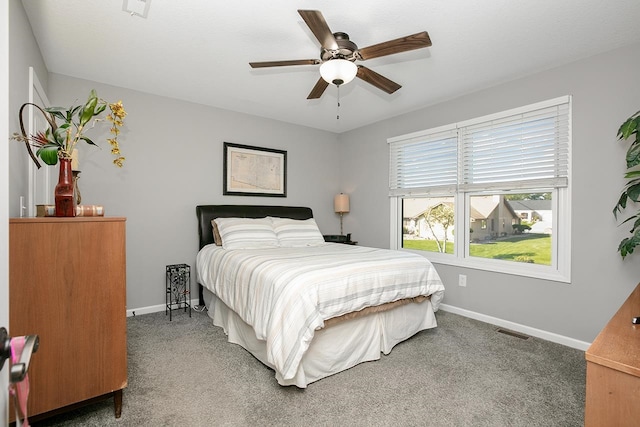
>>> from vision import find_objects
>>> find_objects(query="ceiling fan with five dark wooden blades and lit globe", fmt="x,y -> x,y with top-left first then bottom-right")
249,10 -> 431,99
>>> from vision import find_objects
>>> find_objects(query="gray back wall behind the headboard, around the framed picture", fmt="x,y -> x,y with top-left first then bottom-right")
43,73 -> 342,309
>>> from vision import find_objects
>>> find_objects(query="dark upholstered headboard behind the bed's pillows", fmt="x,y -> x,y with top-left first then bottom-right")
196,205 -> 313,306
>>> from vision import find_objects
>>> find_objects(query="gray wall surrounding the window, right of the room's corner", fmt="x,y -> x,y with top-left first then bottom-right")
340,45 -> 640,342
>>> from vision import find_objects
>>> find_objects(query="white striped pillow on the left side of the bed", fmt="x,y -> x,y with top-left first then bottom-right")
213,218 -> 278,249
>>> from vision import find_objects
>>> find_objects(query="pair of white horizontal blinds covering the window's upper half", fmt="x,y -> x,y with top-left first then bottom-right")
388,96 -> 571,196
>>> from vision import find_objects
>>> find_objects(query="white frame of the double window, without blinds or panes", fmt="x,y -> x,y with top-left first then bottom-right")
388,96 -> 572,283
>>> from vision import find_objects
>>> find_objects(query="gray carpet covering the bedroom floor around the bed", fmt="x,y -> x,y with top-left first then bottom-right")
34,311 -> 585,427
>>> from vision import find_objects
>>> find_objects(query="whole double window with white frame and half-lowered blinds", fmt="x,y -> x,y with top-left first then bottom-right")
388,96 -> 571,282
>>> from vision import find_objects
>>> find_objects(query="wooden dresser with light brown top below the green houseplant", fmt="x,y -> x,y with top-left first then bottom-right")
584,285 -> 640,427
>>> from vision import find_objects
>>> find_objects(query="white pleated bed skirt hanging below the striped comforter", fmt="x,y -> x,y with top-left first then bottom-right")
204,288 -> 437,388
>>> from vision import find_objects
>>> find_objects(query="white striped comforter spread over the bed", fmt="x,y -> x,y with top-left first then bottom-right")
196,243 -> 444,379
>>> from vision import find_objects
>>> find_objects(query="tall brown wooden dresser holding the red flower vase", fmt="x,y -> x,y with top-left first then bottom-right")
9,217 -> 127,421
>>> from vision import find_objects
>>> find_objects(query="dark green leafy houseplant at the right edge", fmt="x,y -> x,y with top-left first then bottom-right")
613,111 -> 640,259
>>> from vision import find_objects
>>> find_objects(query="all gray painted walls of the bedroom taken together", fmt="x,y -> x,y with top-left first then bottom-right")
9,2 -> 640,342
